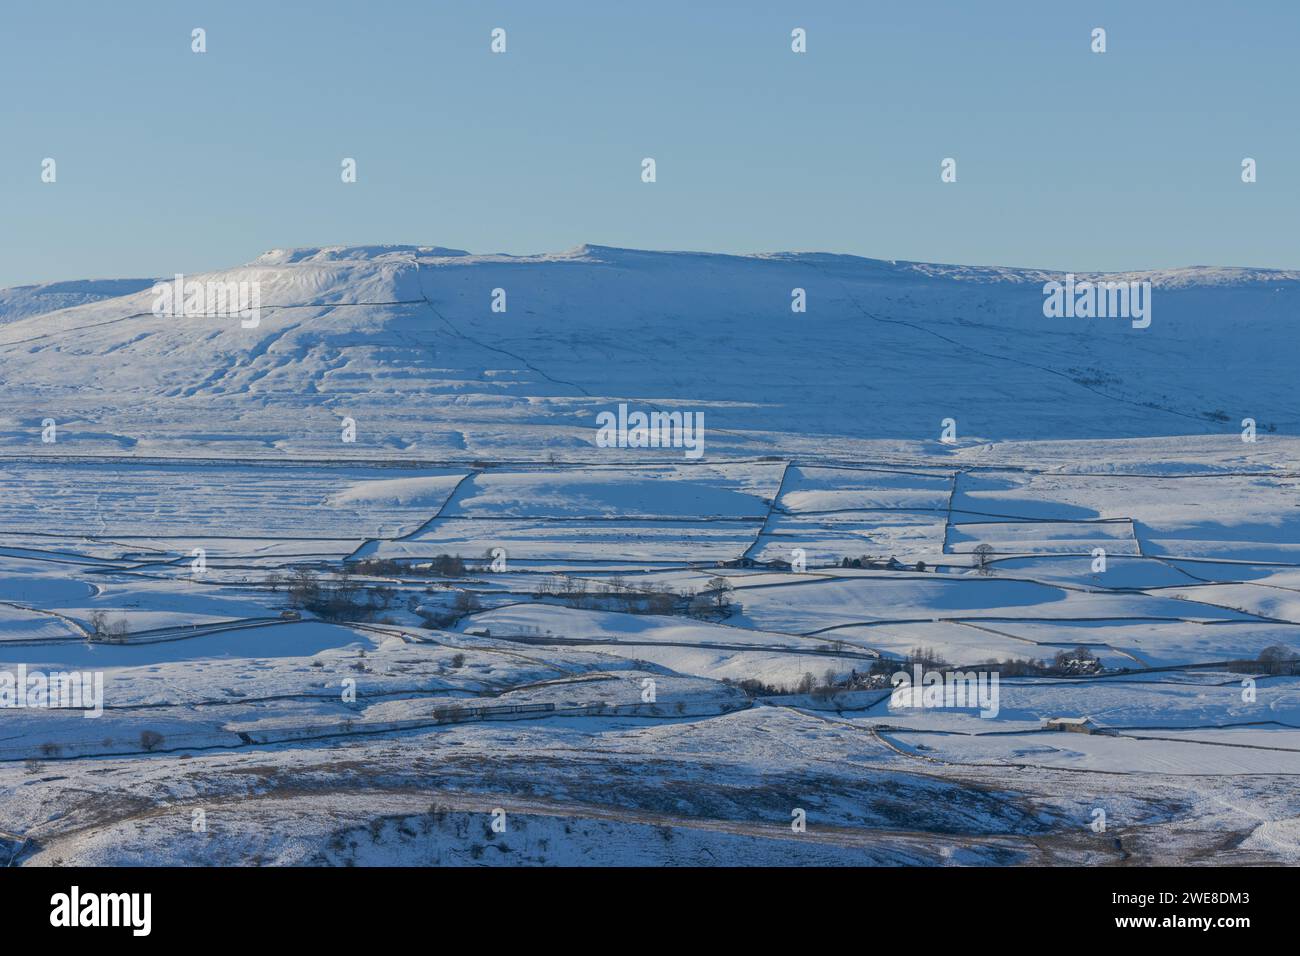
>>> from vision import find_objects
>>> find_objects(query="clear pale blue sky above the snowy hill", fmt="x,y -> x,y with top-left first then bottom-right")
0,0 -> 1300,286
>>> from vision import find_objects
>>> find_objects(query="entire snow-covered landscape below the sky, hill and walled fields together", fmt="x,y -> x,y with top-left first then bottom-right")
0,246 -> 1300,865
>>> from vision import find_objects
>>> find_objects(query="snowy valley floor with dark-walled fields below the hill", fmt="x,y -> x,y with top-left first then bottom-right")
0,440 -> 1300,865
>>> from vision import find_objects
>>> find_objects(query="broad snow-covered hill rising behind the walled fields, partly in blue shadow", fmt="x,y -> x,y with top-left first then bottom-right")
0,246 -> 1300,459
